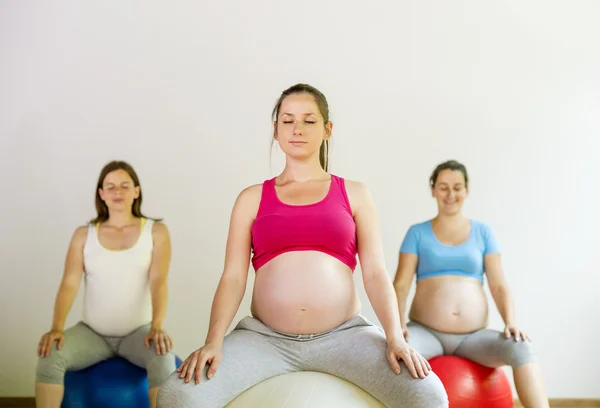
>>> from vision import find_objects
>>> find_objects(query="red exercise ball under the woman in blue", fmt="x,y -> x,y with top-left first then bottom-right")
429,356 -> 514,408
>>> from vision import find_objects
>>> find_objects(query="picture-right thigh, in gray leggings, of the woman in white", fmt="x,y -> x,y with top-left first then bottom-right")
117,325 -> 175,388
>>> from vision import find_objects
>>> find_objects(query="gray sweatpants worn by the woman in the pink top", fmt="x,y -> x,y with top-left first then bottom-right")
157,315 -> 448,408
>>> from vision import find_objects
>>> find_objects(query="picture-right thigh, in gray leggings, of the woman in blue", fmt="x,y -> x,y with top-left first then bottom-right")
454,329 -> 535,368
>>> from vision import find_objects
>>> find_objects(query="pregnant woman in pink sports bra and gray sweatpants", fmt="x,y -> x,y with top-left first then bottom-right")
158,84 -> 448,408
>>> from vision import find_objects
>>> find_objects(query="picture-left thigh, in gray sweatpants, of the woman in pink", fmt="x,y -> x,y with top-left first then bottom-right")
157,329 -> 299,408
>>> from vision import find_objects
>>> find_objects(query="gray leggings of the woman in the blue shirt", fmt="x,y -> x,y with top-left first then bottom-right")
407,321 -> 535,368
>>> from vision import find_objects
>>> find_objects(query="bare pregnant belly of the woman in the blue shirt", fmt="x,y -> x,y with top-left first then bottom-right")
409,276 -> 488,333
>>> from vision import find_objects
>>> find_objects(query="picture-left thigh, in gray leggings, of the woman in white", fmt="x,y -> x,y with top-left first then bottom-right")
39,322 -> 114,370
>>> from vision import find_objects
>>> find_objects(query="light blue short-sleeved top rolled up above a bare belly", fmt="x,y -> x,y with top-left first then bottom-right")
400,220 -> 500,283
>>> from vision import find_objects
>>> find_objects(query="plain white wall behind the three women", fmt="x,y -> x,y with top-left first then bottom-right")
0,0 -> 600,398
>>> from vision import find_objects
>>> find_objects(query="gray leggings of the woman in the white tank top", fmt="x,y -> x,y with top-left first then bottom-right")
36,322 -> 175,388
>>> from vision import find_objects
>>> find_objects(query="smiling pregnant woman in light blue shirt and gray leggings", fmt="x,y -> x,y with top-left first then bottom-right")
394,161 -> 549,407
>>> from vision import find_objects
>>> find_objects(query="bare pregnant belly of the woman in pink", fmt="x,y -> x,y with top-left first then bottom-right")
252,251 -> 360,334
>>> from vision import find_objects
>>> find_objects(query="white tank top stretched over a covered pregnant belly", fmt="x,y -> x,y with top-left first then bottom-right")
83,218 -> 154,337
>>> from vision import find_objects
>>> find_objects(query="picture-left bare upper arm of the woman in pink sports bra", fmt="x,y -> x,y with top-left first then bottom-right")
223,184 -> 262,281
